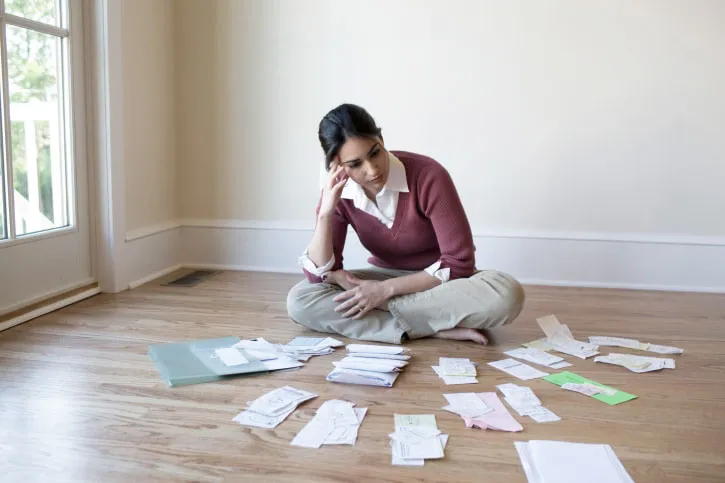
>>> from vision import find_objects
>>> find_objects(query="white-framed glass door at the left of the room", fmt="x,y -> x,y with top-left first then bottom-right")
0,0 -> 94,325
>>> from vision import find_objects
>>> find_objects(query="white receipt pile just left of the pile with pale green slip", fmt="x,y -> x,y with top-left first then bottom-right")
291,399 -> 367,448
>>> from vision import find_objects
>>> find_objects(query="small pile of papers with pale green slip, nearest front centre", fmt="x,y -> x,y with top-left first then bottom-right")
388,414 -> 448,466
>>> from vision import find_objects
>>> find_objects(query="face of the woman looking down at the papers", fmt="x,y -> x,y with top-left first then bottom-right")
338,137 -> 390,195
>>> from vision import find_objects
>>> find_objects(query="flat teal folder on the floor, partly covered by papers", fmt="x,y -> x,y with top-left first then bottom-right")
148,337 -> 269,387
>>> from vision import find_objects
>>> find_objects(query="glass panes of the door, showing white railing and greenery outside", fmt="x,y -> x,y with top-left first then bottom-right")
0,0 -> 73,243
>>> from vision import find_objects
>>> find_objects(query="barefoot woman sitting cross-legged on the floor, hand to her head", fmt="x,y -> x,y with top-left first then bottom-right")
287,104 -> 524,345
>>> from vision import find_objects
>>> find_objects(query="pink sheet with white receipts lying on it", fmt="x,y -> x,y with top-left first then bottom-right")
443,392 -> 524,431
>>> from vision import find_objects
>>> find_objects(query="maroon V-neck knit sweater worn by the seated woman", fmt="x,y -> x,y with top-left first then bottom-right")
303,151 -> 476,283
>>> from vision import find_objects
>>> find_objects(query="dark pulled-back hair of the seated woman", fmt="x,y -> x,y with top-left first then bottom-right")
317,104 -> 382,170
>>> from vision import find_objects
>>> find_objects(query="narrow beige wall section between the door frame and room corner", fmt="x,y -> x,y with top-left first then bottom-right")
121,0 -> 178,234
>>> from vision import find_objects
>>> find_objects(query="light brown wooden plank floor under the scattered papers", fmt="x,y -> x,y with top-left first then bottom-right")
0,272 -> 725,483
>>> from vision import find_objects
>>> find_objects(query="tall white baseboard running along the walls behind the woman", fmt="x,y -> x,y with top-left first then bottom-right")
120,220 -> 725,293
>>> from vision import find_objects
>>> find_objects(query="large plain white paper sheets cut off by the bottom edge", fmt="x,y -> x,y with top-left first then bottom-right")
514,441 -> 634,483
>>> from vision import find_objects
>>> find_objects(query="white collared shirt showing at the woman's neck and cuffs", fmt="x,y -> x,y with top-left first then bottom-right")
299,152 -> 451,282
